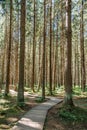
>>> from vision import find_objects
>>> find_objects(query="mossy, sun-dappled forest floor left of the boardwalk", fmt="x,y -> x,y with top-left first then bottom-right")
0,90 -> 46,130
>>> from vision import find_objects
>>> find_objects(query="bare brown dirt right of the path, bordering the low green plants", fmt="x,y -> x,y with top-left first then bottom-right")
44,99 -> 87,130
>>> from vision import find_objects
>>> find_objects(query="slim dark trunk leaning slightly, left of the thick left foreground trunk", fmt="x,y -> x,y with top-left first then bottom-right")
5,0 -> 13,96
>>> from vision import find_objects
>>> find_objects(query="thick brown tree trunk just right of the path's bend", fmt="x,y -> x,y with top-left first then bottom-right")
64,0 -> 73,106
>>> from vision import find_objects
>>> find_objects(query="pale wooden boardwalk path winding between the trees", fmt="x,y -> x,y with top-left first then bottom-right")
11,97 -> 62,130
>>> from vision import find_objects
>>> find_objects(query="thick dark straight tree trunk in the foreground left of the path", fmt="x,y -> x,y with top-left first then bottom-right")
18,0 -> 26,105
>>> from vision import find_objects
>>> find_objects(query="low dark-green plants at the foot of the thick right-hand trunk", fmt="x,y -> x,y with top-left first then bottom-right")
59,106 -> 87,122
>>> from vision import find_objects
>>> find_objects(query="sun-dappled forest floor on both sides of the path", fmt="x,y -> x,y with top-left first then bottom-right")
0,89 -> 87,130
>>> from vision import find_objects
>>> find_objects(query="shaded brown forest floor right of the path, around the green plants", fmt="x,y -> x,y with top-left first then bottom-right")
44,98 -> 87,130
